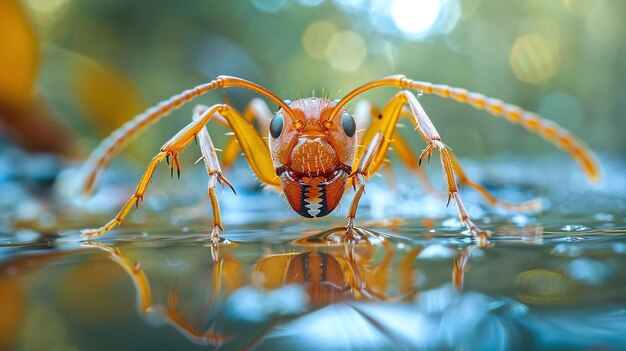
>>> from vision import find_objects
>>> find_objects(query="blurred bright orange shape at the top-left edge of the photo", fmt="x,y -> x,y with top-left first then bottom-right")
0,0 -> 39,108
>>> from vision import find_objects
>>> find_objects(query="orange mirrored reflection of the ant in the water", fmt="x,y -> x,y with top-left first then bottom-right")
83,228 -> 473,346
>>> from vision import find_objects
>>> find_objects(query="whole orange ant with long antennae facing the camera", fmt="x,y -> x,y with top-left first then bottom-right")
77,75 -> 599,243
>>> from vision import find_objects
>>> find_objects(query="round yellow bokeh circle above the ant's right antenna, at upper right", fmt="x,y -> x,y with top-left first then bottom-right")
509,34 -> 559,84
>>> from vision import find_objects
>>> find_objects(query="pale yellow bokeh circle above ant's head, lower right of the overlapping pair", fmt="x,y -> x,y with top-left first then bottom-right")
326,31 -> 367,72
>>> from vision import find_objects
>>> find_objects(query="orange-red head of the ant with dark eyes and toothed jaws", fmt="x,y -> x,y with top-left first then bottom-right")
269,98 -> 356,217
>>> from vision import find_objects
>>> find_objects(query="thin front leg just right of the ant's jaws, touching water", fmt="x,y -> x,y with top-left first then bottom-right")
346,132 -> 383,241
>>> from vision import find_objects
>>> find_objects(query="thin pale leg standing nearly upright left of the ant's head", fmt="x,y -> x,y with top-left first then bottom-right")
193,105 -> 237,244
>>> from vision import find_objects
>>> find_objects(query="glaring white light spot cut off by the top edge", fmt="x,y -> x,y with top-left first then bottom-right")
391,0 -> 442,35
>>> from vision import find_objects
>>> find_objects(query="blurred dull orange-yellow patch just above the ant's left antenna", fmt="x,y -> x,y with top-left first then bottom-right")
73,59 -> 144,136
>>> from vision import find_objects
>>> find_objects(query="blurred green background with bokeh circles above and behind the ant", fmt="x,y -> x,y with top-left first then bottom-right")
2,0 -> 626,162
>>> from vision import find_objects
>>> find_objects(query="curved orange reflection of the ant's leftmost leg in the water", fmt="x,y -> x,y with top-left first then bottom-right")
82,241 -> 230,345
